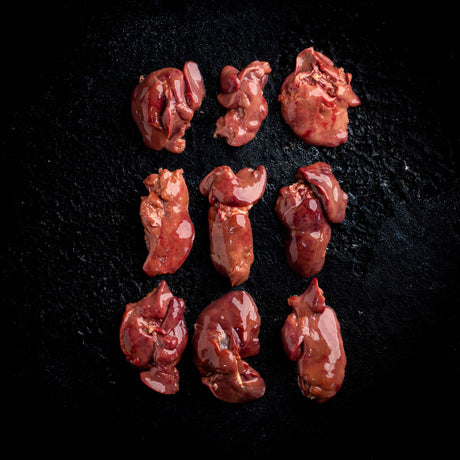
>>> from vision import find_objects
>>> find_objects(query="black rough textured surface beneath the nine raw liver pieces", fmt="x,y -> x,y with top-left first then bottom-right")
2,0 -> 460,458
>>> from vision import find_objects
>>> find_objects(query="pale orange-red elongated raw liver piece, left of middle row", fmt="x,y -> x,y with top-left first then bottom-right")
140,168 -> 195,276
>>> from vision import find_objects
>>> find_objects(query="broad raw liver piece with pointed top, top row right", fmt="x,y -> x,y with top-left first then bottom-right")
278,48 -> 361,147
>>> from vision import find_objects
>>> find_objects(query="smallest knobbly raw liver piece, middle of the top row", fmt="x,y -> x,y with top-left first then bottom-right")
214,61 -> 271,147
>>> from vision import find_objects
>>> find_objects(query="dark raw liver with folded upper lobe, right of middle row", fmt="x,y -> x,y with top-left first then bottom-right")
276,162 -> 348,278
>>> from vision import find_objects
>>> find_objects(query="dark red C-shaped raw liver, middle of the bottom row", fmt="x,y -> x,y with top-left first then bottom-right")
193,291 -> 265,403
